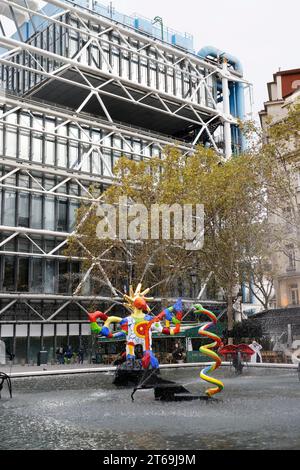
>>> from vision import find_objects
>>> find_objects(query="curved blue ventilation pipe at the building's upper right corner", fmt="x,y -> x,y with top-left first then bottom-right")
198,46 -> 246,152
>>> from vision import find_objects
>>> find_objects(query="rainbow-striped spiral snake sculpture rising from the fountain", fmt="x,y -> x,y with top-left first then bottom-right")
195,305 -> 224,398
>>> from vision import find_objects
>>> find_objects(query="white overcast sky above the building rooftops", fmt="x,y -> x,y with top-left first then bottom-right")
110,0 -> 300,117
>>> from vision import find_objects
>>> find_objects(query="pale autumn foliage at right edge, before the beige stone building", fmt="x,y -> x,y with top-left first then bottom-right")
239,100 -> 300,309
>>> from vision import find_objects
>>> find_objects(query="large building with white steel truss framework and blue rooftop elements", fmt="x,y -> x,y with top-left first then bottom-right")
0,0 -> 248,363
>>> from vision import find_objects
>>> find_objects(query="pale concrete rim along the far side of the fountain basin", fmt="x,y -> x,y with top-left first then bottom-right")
7,362 -> 298,378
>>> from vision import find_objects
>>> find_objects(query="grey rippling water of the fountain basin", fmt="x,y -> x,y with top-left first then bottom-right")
0,368 -> 300,450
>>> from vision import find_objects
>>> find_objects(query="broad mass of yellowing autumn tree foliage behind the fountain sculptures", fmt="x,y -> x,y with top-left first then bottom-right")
68,141 -> 292,336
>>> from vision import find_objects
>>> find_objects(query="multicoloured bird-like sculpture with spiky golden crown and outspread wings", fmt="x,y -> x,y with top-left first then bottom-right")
89,284 -> 182,369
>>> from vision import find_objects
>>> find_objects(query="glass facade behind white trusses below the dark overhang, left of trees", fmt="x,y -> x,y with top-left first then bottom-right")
0,105 -> 166,364
